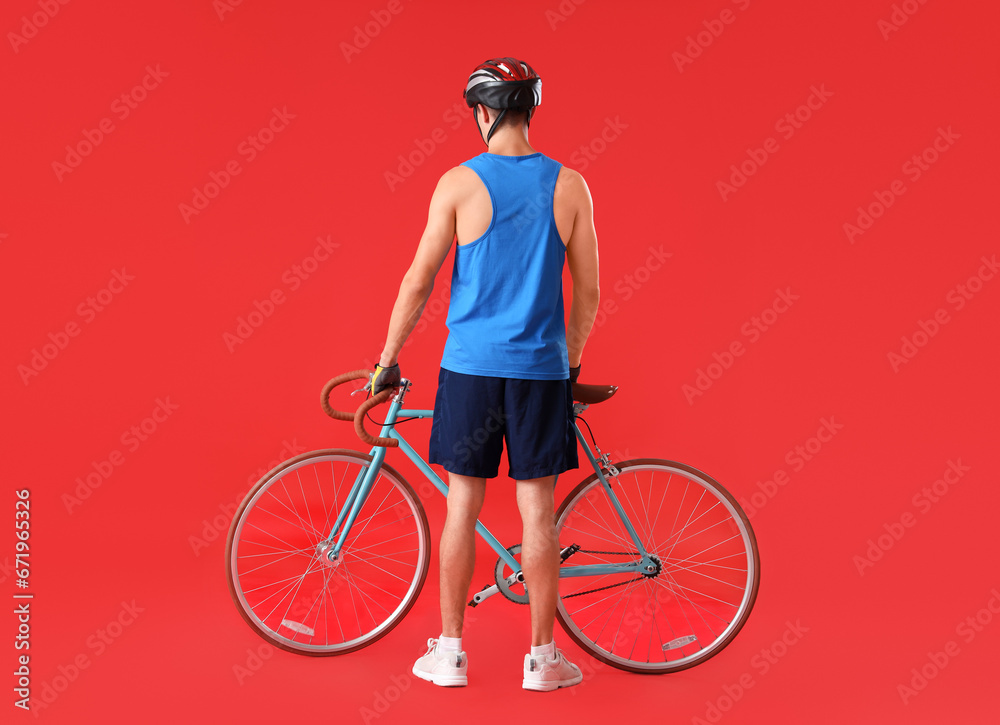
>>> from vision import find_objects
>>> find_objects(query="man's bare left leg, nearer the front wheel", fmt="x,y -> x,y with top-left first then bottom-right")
441,473 -> 486,637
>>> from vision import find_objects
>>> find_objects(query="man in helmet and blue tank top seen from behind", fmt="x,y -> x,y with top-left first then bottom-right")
372,58 -> 599,690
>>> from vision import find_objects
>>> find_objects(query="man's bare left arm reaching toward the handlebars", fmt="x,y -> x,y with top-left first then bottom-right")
379,169 -> 458,367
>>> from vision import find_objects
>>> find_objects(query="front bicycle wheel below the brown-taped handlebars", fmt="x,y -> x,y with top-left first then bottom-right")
226,449 -> 430,656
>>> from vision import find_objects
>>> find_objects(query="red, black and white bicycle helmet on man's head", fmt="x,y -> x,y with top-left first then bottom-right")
462,58 -> 542,144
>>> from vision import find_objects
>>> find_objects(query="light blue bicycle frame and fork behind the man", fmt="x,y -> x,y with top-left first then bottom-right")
326,378 -> 655,577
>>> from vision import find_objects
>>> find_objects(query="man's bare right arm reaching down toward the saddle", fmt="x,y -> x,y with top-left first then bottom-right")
565,171 -> 601,368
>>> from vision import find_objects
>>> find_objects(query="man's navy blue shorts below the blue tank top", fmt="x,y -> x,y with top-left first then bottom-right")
429,368 -> 579,481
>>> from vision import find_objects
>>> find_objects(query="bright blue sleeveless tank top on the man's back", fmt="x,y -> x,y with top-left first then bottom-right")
441,153 -> 569,380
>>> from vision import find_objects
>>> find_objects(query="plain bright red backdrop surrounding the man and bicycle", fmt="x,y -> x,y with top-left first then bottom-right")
0,0 -> 1000,723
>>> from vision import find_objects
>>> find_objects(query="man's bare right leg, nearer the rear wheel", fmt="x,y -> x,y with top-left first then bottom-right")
517,476 -> 560,647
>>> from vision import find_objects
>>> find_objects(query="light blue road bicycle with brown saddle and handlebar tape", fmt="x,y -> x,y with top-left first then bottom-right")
226,370 -> 760,673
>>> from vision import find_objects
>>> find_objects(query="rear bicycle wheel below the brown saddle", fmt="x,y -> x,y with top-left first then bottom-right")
556,458 -> 760,673
